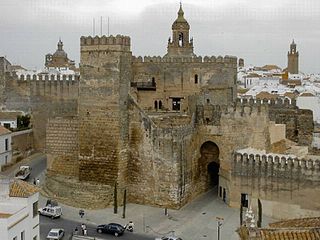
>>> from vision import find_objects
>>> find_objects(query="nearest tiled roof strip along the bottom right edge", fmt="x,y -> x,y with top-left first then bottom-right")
259,228 -> 320,240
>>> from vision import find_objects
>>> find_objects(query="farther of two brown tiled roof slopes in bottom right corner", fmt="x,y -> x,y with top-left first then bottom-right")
269,217 -> 320,228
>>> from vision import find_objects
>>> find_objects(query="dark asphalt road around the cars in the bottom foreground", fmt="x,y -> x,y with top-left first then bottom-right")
40,216 -> 154,240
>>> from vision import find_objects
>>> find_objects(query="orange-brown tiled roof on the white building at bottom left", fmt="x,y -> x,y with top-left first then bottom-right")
9,179 -> 39,198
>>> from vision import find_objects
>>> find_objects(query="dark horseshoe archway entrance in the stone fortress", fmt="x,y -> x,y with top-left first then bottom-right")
200,141 -> 220,189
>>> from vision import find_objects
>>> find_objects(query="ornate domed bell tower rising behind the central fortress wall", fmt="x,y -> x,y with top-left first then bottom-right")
166,3 -> 195,57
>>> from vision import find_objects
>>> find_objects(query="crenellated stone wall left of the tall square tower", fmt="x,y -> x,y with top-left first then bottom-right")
2,76 -> 79,150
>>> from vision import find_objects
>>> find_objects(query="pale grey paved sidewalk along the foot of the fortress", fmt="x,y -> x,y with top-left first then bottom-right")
40,190 -> 271,240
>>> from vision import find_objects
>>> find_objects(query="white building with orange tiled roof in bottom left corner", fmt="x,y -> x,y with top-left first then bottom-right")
0,179 -> 40,240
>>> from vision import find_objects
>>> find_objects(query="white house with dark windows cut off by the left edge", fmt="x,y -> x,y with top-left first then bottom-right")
0,126 -> 12,170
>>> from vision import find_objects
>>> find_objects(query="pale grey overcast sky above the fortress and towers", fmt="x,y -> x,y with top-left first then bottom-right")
0,0 -> 320,73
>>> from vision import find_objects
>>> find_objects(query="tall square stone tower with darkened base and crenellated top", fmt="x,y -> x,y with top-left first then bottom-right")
79,35 -> 132,186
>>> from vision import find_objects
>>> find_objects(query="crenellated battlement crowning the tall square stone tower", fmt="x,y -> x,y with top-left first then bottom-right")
80,34 -> 130,47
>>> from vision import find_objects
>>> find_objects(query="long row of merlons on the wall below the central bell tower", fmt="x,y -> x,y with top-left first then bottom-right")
132,56 -> 237,64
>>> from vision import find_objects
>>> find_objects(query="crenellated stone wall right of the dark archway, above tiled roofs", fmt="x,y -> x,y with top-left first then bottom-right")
232,152 -> 320,217
